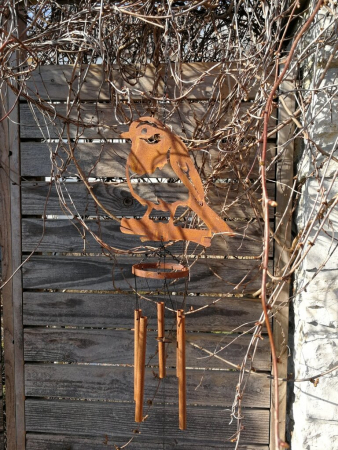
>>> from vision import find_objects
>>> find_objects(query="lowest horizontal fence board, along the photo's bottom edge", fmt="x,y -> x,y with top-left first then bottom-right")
26,433 -> 269,450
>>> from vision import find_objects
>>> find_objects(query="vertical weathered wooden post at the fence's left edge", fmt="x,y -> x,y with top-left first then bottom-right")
0,67 -> 25,450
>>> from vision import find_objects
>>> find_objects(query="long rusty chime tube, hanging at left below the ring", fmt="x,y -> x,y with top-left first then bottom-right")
135,317 -> 147,422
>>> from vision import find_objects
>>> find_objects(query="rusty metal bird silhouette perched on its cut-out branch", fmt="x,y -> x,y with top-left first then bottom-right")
121,117 -> 233,247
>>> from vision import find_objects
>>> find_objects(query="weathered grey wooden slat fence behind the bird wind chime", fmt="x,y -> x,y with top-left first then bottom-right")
1,65 -> 289,450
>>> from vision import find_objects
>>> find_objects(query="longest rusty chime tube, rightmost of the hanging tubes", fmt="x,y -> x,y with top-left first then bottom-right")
177,310 -> 187,430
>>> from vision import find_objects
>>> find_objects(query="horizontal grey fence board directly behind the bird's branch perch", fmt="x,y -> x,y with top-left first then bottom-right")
22,218 -> 272,257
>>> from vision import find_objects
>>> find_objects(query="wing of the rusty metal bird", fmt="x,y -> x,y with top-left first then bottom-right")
170,154 -> 204,204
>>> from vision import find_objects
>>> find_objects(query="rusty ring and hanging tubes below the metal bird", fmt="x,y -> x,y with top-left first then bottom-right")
132,255 -> 189,430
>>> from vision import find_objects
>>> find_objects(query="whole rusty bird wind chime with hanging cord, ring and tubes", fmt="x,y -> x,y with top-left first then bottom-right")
121,19 -> 233,430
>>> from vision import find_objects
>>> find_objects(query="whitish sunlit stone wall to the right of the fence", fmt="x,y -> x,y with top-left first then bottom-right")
290,2 -> 338,450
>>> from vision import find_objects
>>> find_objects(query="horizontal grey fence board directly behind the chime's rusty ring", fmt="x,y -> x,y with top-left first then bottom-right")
23,256 -> 270,294
